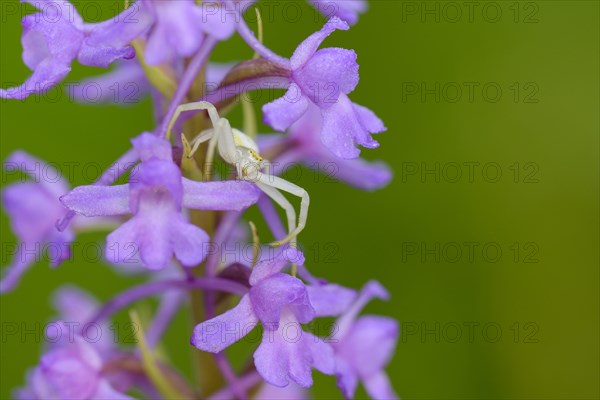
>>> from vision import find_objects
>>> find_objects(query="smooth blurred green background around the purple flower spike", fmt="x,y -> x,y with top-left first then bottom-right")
0,0 -> 599,399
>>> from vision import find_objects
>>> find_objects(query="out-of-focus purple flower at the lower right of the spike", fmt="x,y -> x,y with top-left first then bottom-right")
331,281 -> 399,400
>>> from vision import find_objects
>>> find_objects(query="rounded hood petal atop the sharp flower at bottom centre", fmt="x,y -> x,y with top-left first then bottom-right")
250,273 -> 315,330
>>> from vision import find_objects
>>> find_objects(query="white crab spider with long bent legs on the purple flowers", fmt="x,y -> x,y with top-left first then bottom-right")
167,101 -> 310,246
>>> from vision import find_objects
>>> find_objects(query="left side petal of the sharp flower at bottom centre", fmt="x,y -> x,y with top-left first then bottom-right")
190,295 -> 258,353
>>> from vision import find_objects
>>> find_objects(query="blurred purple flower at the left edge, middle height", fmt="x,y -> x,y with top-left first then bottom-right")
0,151 -> 81,293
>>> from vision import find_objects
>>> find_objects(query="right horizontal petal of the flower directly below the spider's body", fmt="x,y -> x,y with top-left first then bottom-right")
182,178 -> 261,211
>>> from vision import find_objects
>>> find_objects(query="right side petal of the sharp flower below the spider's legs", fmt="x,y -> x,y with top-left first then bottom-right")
306,284 -> 356,317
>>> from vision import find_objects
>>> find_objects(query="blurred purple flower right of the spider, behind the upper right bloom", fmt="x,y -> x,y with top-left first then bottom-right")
258,104 -> 392,190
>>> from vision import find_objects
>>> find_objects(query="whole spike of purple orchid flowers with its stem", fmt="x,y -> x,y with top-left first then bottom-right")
0,0 -> 399,399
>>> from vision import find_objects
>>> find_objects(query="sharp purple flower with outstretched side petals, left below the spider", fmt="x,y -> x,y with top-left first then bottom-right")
60,133 -> 260,270
